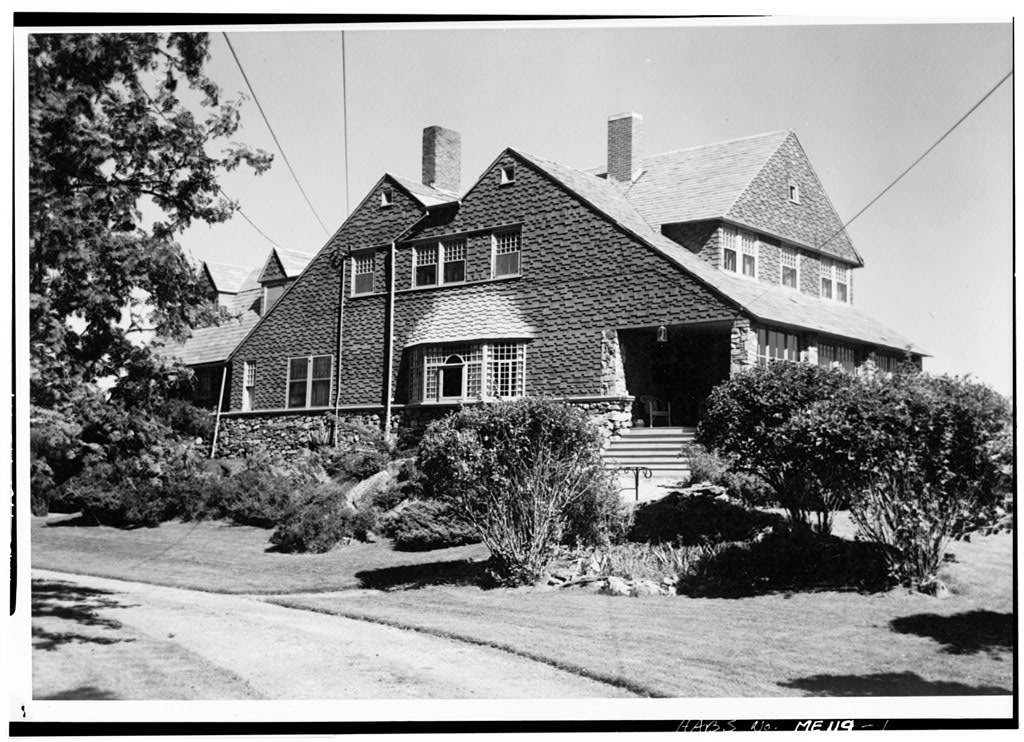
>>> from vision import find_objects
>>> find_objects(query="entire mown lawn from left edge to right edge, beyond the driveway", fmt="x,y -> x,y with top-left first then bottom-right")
32,505 -> 1016,697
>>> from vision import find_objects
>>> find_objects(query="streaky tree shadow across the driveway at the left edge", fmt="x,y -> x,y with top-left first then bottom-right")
32,579 -> 135,651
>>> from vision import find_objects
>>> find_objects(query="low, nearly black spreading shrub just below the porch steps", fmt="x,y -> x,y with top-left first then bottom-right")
628,492 -> 781,545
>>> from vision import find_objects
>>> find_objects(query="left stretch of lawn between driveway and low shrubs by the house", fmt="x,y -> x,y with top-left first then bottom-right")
32,515 -> 488,595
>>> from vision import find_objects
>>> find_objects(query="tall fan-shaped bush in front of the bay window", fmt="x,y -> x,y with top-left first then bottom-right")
419,398 -> 612,584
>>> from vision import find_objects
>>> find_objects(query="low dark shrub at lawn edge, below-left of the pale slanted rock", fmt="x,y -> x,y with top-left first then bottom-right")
270,481 -> 356,554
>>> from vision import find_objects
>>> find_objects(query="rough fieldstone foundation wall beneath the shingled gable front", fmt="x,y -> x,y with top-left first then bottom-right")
217,396 -> 633,459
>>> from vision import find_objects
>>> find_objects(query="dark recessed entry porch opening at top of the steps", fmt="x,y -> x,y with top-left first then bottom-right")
616,321 -> 732,427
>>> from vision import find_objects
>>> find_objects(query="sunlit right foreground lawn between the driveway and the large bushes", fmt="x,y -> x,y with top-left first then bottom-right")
272,535 -> 1016,697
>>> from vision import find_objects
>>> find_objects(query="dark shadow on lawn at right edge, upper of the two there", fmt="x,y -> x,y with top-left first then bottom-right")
889,610 -> 1017,654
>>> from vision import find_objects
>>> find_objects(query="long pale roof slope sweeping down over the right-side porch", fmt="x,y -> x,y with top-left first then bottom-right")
510,149 -> 924,354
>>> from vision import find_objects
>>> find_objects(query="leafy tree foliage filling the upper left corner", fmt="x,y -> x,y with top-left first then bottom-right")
29,33 -> 270,405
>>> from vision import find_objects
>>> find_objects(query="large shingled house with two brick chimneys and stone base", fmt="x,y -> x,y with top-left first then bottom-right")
174,114 -> 922,453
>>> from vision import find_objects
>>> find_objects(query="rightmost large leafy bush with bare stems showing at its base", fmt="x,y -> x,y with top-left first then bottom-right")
806,374 -> 1013,585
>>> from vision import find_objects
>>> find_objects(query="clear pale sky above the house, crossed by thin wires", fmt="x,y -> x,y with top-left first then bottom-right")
167,20 -> 1013,394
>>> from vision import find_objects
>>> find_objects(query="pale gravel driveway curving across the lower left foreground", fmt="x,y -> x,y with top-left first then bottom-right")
32,570 -> 631,699
